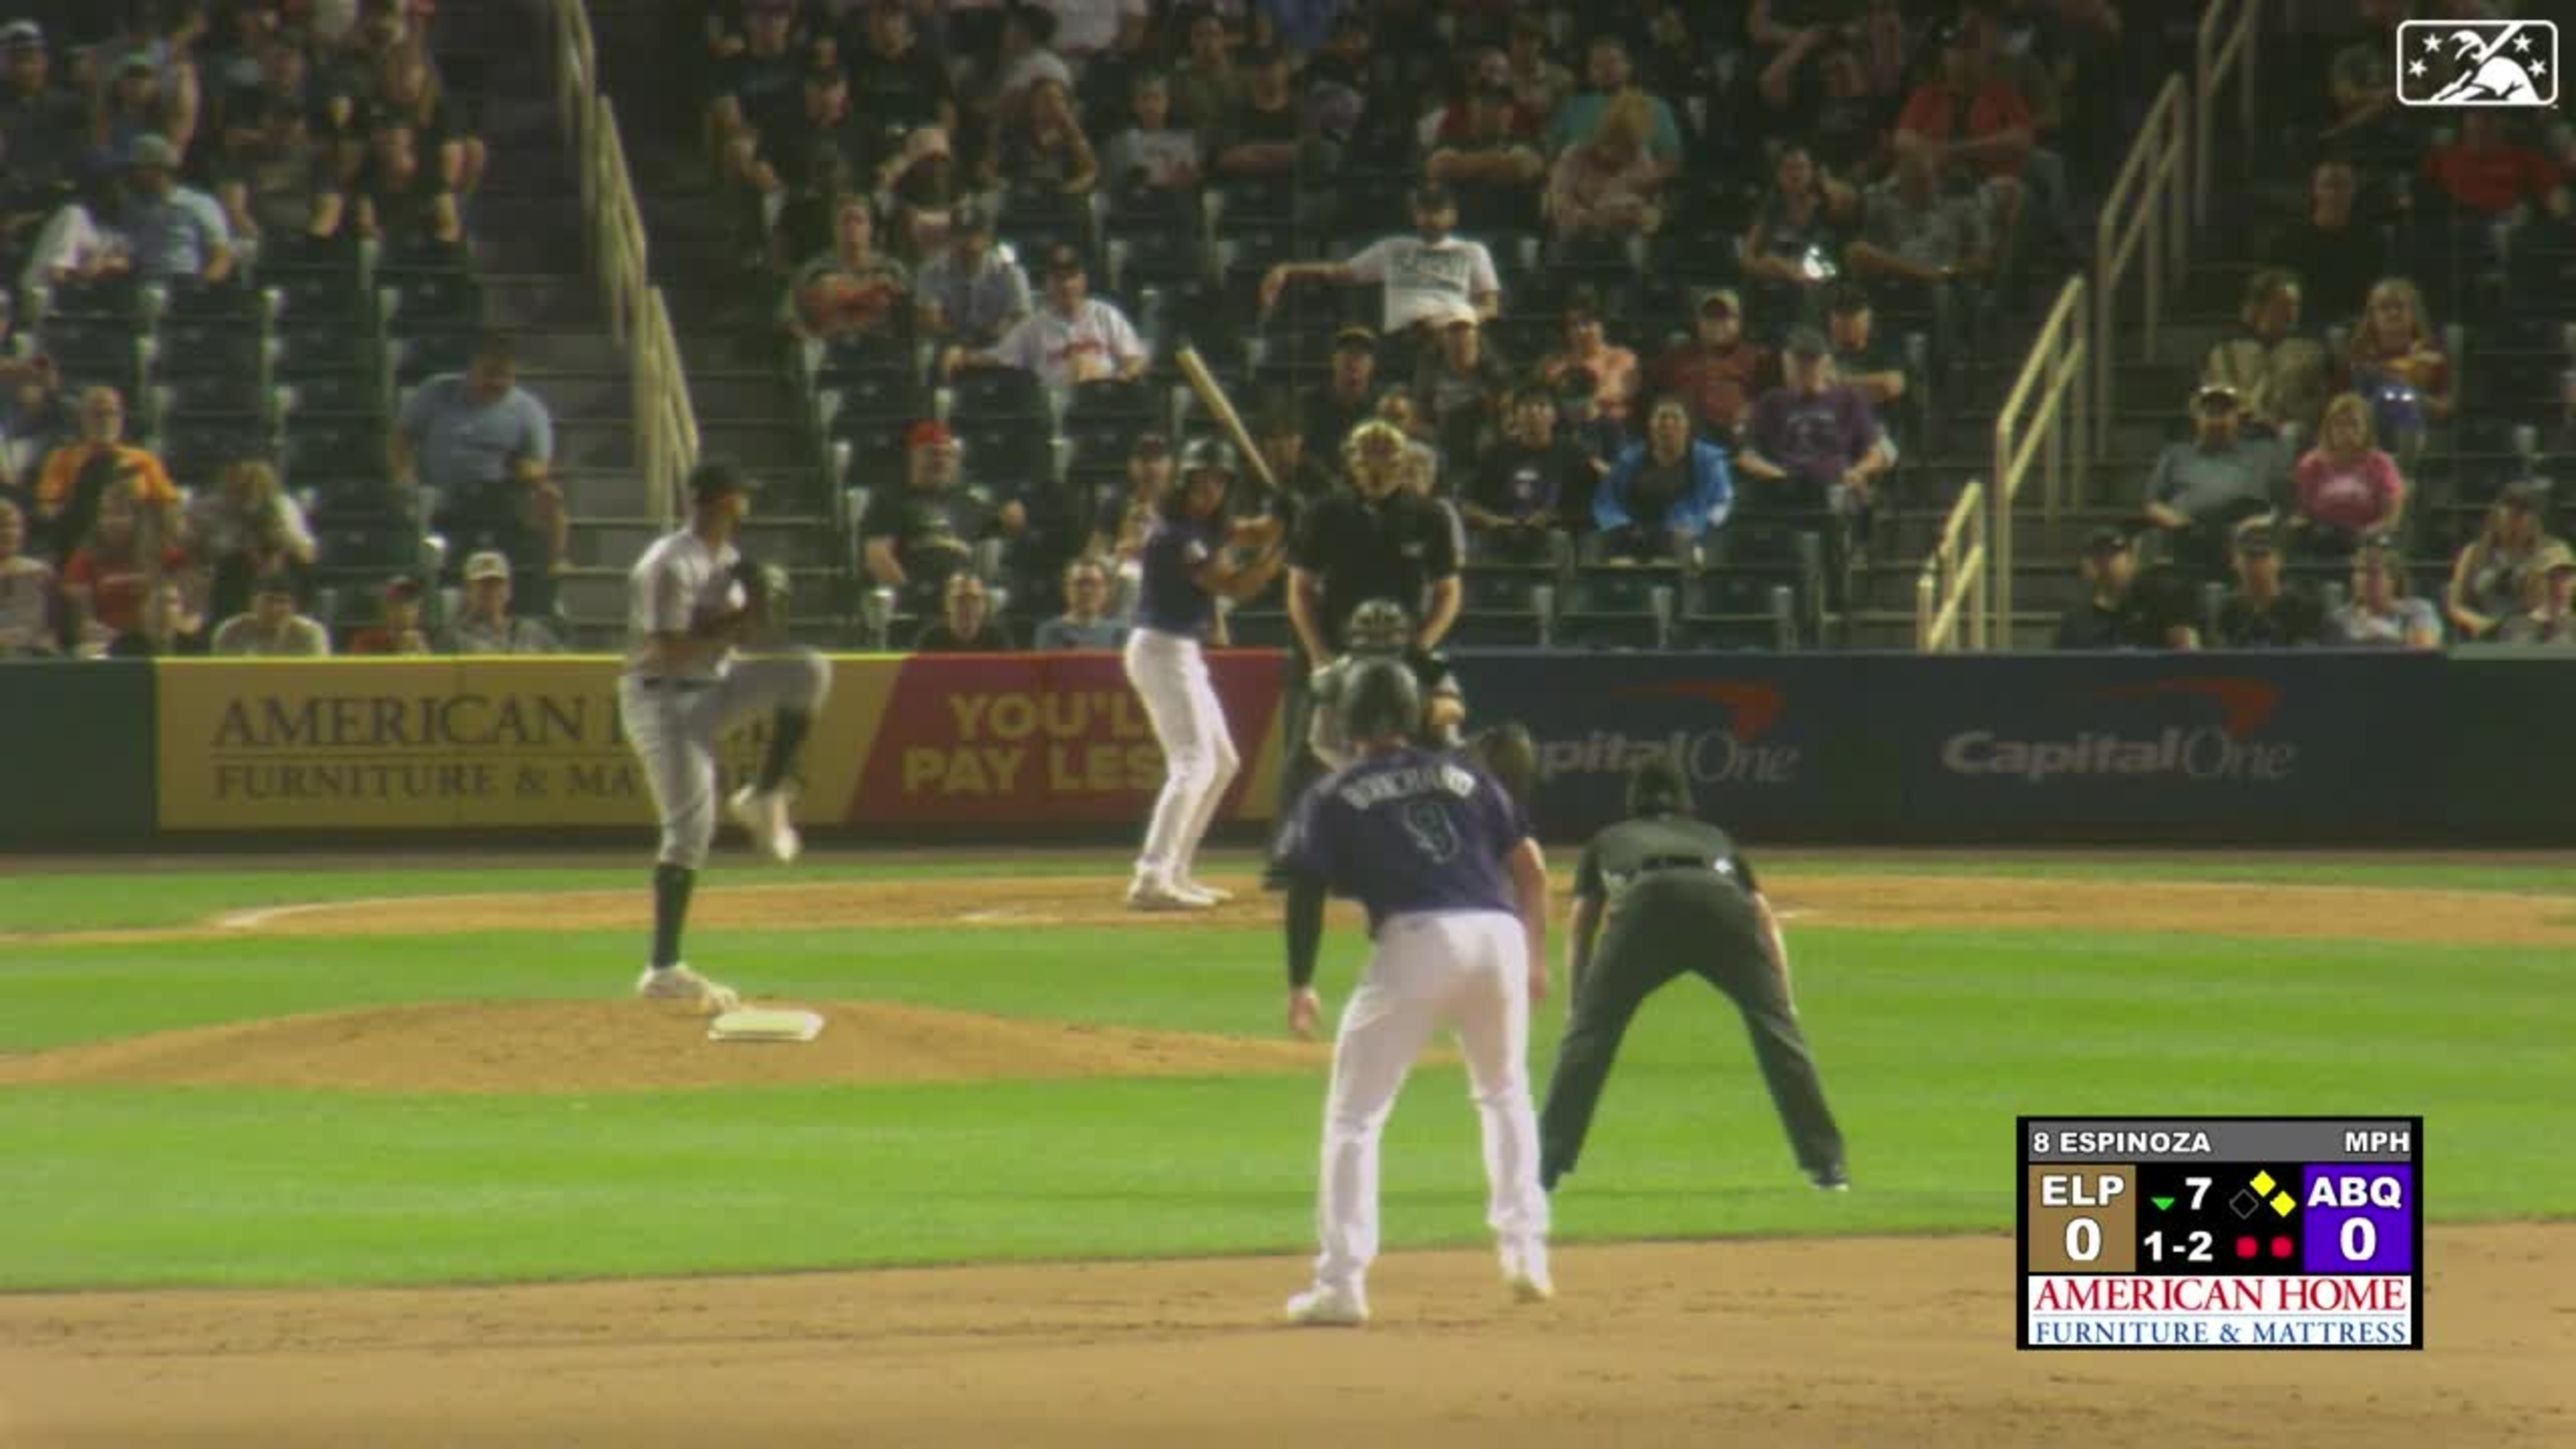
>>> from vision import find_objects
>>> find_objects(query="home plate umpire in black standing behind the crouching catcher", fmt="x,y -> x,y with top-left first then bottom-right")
1265,423 -> 1461,887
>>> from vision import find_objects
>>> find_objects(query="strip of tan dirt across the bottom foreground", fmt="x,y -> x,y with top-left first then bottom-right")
0,1207 -> 2576,1449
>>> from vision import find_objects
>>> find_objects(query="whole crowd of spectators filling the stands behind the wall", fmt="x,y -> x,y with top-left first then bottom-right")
0,0 -> 2576,652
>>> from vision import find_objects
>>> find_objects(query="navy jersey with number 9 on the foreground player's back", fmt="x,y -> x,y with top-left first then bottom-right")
1280,748 -> 1530,931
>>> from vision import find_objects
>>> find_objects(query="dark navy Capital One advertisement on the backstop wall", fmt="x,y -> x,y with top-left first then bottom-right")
1461,652 -> 2442,843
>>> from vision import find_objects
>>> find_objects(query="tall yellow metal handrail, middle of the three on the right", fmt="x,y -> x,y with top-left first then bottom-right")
1986,276 -> 2107,645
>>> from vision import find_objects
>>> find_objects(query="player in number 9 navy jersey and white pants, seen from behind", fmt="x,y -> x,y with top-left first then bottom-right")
1280,660 -> 1556,1323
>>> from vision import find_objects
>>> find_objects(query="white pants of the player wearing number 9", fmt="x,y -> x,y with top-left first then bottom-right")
1314,910 -> 1548,1292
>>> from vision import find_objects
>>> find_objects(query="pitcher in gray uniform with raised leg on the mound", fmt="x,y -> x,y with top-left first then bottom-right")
618,464 -> 832,1011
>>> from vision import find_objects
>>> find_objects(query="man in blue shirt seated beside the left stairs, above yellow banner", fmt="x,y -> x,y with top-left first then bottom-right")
391,335 -> 572,611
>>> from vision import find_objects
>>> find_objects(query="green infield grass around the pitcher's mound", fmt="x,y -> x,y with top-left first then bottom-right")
0,859 -> 2576,1289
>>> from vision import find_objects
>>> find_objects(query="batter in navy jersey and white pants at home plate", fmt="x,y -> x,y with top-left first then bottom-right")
1126,438 -> 1288,910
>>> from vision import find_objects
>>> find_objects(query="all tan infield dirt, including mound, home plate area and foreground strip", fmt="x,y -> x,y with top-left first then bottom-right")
0,874 -> 2576,1449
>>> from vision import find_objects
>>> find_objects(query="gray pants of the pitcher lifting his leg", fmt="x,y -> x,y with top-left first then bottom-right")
618,650 -> 832,869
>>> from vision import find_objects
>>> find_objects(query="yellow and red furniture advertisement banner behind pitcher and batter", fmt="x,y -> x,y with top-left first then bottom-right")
152,655 -> 1278,830
